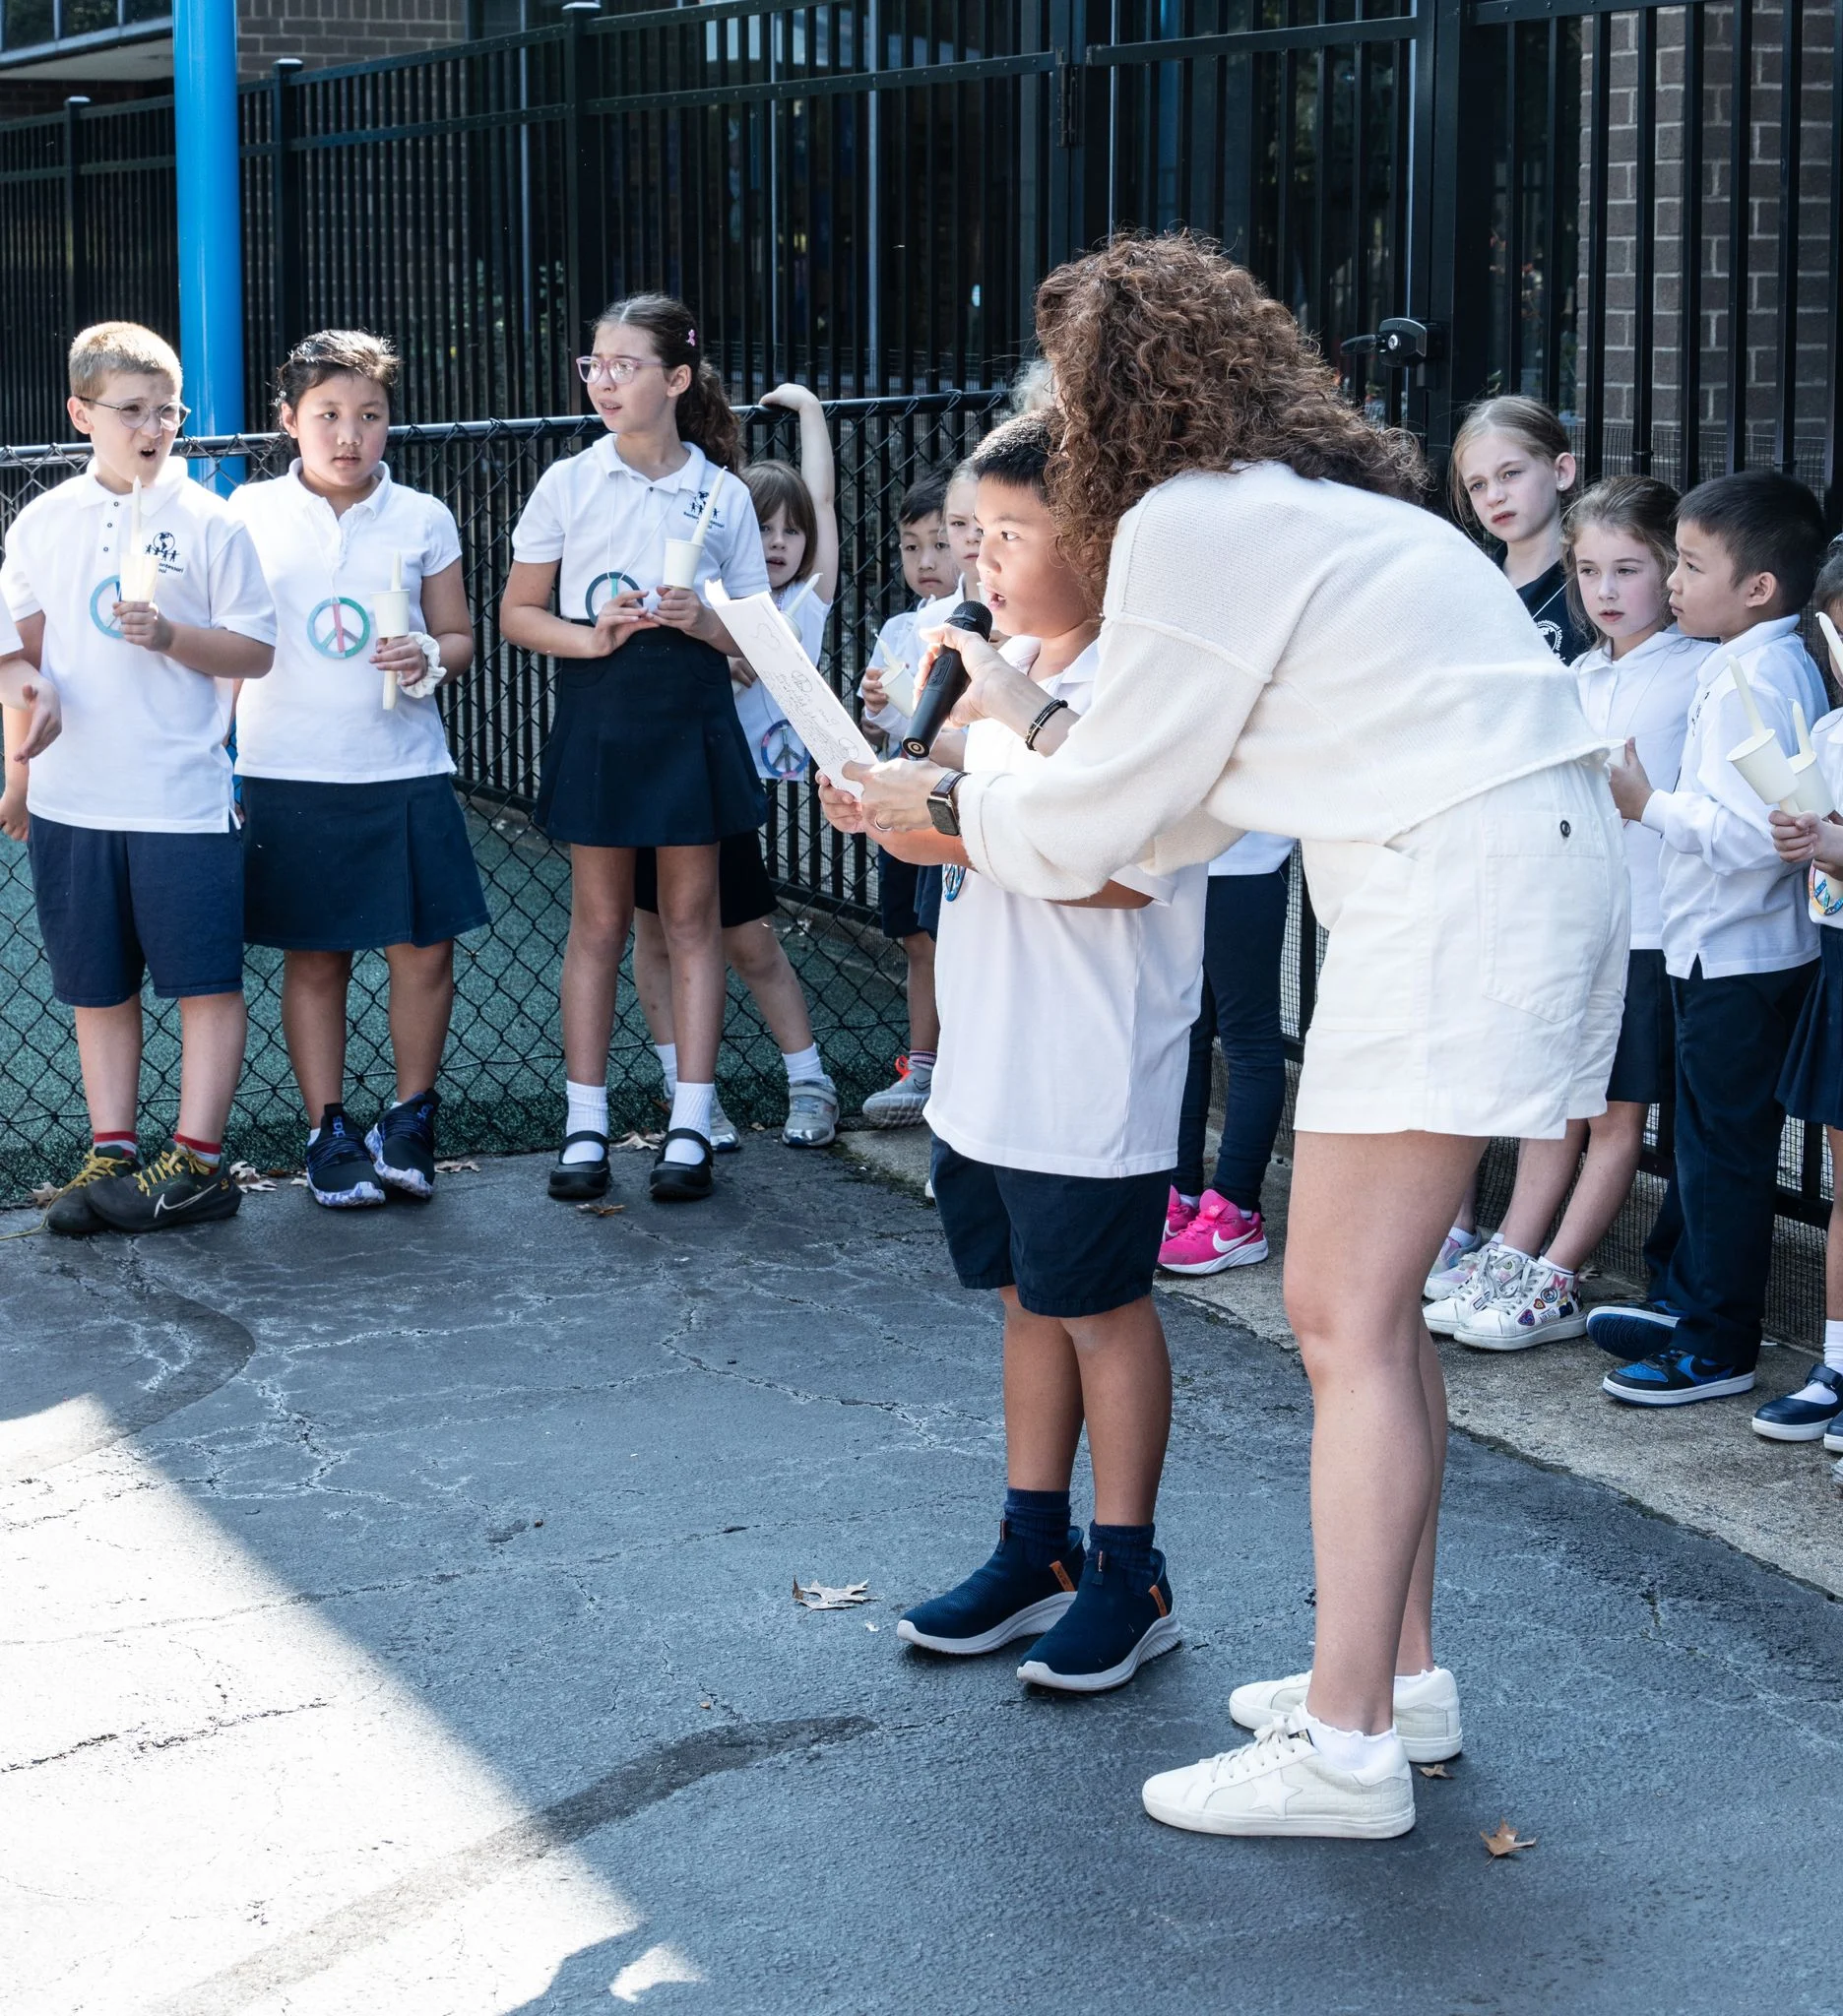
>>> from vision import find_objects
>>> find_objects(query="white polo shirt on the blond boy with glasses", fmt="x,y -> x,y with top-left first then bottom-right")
0,456 -> 275,833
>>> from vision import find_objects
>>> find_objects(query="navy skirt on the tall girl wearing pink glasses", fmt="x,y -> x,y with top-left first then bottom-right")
533,629 -> 768,847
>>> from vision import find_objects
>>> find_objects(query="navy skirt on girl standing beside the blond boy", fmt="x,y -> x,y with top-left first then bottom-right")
242,776 -> 488,952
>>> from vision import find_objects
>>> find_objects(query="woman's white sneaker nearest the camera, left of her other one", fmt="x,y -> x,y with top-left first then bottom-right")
1139,1710 -> 1414,1841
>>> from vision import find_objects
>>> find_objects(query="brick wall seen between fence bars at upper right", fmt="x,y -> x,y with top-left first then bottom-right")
1579,0 -> 1839,473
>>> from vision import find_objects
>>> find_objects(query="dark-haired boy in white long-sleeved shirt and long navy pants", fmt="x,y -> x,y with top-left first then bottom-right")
1587,470 -> 1829,1408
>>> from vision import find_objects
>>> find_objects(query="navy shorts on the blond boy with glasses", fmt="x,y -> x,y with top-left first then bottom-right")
31,812 -> 244,1008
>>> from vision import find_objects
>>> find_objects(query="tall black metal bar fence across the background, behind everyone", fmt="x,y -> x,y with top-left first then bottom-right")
0,0 -> 1843,524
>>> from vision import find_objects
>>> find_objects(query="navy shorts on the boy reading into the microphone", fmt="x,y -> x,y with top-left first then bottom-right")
933,1141 -> 1172,1316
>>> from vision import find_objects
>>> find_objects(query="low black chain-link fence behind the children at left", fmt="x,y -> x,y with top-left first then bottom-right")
0,391 -> 1002,1198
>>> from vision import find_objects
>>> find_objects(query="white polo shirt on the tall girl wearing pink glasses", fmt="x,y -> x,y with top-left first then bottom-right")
512,433 -> 768,623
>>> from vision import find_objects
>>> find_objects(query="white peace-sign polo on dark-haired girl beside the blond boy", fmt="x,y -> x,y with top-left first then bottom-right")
229,462 -> 460,785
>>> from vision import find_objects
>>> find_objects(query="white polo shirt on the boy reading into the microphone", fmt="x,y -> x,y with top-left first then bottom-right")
927,637 -> 1208,1177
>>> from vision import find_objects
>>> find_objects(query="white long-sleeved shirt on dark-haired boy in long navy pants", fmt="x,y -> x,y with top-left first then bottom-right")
1643,617 -> 1825,979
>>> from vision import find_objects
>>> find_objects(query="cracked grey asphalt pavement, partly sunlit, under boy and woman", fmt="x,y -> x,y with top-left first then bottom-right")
0,1139 -> 1843,2016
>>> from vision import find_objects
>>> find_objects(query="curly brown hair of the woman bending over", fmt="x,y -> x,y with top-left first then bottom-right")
1037,232 -> 1428,585
